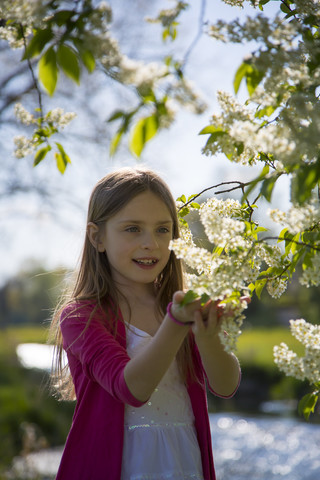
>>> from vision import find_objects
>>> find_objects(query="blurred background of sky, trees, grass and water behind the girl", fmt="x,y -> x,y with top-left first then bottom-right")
0,0 -> 320,480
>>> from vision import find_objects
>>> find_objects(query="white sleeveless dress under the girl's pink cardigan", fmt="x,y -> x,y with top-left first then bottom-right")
121,325 -> 203,480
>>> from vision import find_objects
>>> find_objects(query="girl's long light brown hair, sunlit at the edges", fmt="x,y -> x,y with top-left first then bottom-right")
49,168 -> 194,400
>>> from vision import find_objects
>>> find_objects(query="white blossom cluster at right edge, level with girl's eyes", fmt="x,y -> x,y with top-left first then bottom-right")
268,201 -> 320,235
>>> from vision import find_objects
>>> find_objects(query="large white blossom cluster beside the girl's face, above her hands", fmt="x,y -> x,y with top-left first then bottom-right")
169,198 -> 296,351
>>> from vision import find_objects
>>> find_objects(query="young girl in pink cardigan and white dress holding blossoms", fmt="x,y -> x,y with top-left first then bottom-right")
51,168 -> 240,480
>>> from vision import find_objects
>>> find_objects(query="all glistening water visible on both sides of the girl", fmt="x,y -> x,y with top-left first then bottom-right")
12,344 -> 320,480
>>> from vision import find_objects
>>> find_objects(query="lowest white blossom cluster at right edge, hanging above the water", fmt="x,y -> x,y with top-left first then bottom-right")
273,319 -> 320,384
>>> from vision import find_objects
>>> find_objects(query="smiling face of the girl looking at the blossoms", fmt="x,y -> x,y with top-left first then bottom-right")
98,191 -> 173,287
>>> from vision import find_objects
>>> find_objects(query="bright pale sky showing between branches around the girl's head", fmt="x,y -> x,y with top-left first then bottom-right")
0,0 -> 288,284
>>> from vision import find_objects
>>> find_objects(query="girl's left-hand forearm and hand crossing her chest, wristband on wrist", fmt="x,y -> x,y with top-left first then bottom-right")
124,292 -> 199,402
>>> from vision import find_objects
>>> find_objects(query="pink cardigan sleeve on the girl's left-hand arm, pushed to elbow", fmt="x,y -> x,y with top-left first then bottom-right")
60,306 -> 144,407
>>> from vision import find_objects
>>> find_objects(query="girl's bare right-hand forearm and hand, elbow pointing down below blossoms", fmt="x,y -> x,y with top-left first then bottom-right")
192,303 -> 241,397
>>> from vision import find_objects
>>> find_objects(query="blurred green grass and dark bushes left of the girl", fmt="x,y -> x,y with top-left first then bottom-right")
0,327 -> 74,479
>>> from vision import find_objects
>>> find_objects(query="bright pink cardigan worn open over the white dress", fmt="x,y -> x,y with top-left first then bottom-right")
56,302 -> 239,480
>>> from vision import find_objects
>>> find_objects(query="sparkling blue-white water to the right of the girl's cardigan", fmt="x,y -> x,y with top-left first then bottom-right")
210,414 -> 320,480
